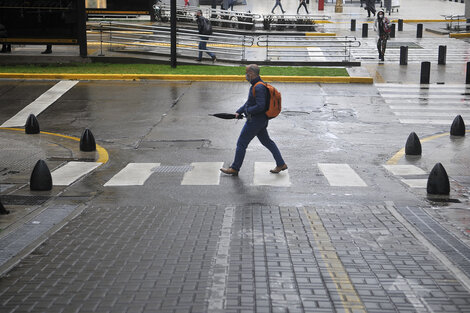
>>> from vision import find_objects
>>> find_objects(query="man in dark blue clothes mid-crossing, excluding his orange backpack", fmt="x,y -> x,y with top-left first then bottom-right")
220,64 -> 287,176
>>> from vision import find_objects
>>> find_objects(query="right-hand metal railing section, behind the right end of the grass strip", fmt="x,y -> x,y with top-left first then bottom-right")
257,35 -> 361,62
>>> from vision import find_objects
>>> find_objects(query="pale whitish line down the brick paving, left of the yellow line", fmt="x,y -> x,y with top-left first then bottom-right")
207,207 -> 235,313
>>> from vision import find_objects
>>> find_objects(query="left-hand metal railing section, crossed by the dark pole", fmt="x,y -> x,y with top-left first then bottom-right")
95,22 -> 254,61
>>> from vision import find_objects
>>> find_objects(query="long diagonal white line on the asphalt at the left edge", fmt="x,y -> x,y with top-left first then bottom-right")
0,80 -> 78,127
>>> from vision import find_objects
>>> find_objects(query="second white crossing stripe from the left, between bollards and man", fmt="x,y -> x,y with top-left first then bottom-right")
104,163 -> 160,187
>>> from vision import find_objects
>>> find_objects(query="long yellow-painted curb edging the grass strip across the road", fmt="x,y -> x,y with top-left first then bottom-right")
0,73 -> 374,84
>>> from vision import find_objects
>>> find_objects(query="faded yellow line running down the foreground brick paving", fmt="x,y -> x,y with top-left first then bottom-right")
304,208 -> 366,313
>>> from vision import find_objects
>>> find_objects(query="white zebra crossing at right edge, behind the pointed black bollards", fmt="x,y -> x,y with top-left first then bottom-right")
375,84 -> 470,127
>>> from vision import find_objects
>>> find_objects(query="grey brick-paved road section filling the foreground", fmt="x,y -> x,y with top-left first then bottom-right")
0,205 -> 470,312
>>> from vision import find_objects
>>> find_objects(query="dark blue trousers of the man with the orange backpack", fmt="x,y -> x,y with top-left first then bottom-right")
230,116 -> 285,171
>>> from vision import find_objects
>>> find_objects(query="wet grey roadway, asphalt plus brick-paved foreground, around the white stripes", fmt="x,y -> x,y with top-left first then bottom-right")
0,81 -> 470,312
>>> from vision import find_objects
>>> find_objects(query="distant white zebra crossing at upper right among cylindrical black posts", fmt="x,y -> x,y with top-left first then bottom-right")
350,34 -> 470,64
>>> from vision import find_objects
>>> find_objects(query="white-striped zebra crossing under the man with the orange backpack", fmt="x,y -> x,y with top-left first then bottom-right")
46,161 -> 436,188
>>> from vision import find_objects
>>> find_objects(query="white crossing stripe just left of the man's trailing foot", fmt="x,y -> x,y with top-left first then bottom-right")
181,162 -> 224,185
